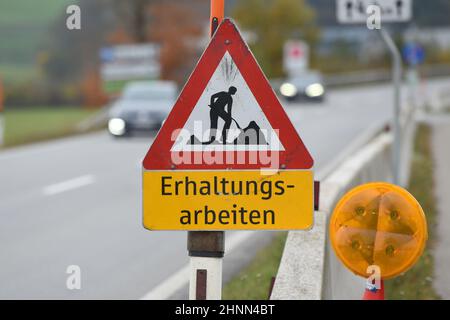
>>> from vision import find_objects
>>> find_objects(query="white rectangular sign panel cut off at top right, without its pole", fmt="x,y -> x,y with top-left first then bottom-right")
336,0 -> 412,23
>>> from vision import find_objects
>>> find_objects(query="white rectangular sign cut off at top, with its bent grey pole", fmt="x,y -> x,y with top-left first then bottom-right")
336,0 -> 413,184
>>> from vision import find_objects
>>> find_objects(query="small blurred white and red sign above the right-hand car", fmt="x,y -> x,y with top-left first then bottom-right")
283,40 -> 309,77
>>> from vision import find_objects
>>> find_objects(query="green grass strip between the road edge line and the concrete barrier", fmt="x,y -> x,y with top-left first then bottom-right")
223,232 -> 287,300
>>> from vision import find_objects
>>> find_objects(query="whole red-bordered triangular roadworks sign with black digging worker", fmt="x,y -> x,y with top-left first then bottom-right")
143,19 -> 313,170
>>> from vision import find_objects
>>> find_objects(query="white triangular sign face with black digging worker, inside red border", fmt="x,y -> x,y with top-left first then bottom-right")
171,51 -> 285,152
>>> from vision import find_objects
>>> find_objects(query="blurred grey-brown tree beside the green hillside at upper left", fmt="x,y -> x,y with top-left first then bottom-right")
40,0 -> 117,106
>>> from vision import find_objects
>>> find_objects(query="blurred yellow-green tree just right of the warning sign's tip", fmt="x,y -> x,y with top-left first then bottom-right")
233,0 -> 319,77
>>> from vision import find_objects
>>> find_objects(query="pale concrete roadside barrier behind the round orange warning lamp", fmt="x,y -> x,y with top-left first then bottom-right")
270,94 -> 416,300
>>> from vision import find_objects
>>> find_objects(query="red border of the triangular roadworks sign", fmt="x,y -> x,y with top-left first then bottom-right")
143,18 -> 314,170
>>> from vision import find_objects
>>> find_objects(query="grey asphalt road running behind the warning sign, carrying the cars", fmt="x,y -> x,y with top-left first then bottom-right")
0,80 -> 449,299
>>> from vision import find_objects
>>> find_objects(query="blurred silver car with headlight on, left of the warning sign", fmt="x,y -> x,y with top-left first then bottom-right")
108,81 -> 177,137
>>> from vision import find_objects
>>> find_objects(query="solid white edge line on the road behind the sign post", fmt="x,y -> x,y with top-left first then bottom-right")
141,231 -> 256,300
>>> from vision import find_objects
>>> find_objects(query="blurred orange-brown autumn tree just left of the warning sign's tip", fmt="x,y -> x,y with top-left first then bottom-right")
107,0 -> 205,84
